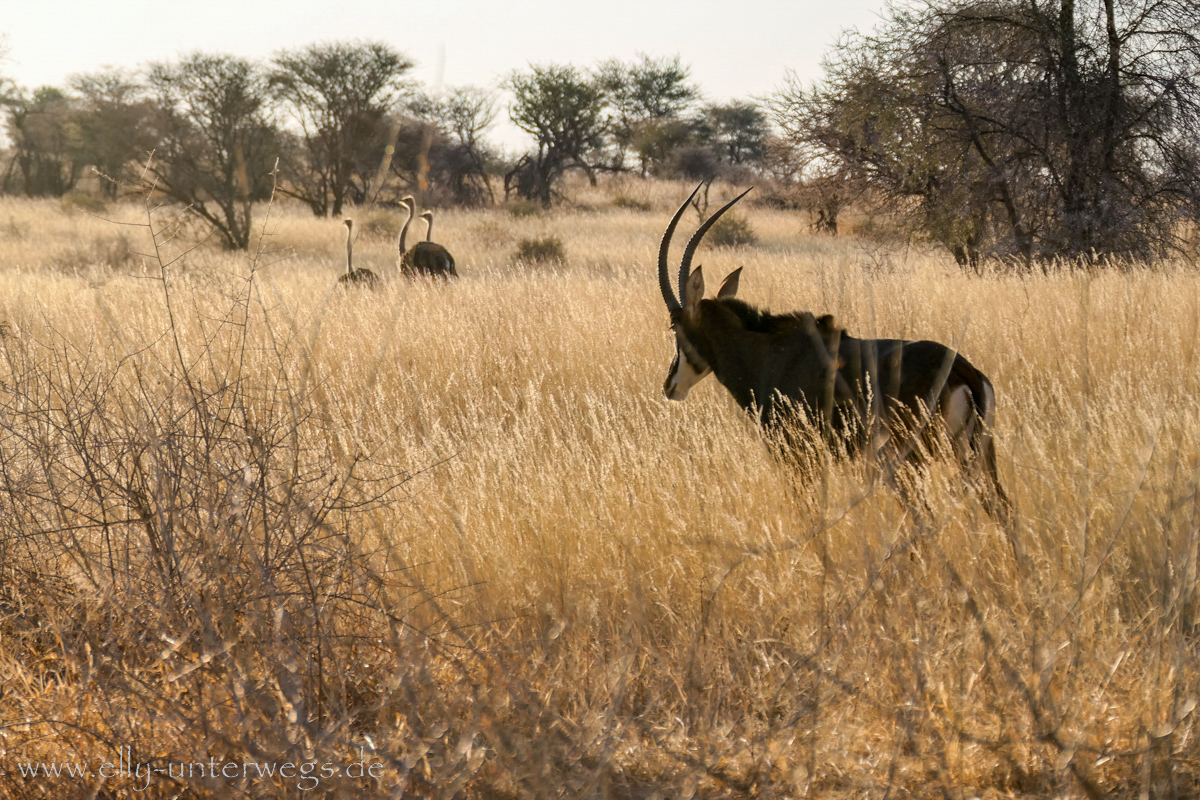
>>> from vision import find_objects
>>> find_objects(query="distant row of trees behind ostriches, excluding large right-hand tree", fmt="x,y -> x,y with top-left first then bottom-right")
0,42 -> 767,248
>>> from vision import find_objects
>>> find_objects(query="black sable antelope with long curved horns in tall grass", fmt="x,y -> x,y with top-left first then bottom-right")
659,187 -> 1009,517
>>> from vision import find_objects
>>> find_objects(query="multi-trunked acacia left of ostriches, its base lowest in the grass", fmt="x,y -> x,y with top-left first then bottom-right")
149,53 -> 284,249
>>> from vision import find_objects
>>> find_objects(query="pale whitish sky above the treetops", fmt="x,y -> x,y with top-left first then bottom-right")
0,0 -> 884,149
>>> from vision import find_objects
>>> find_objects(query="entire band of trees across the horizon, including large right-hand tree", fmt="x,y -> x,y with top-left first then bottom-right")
0,0 -> 1200,266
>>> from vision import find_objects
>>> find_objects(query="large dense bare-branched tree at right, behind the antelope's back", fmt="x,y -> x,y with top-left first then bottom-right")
770,0 -> 1200,263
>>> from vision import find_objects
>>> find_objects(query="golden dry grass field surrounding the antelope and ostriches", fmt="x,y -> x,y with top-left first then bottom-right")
0,182 -> 1200,798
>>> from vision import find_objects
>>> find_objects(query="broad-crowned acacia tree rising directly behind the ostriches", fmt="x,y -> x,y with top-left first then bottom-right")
270,42 -> 413,217
